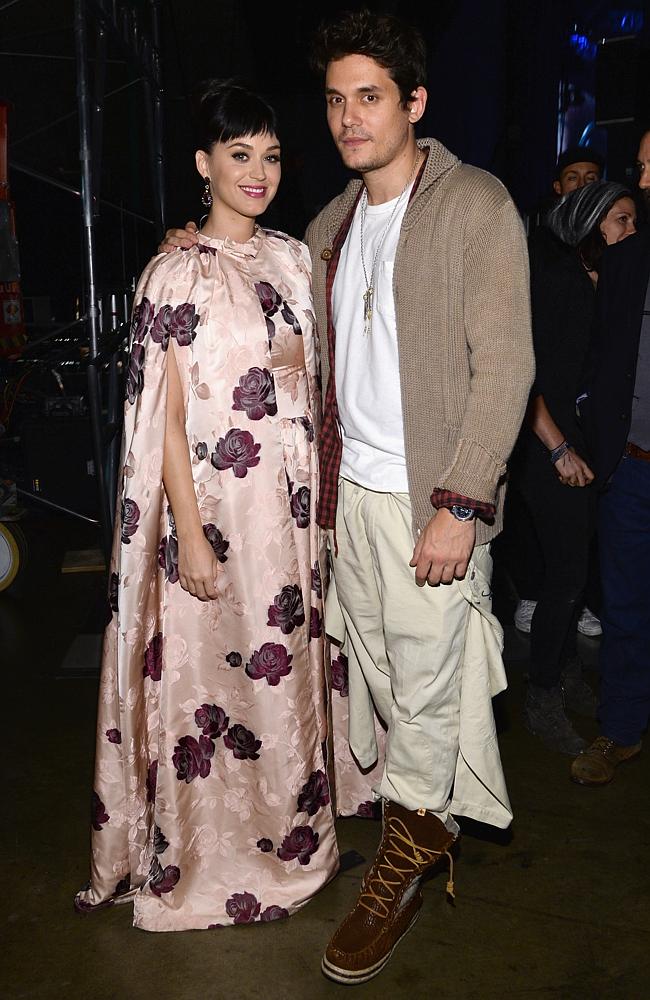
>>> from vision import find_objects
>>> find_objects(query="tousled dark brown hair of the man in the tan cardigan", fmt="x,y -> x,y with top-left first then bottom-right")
311,10 -> 427,106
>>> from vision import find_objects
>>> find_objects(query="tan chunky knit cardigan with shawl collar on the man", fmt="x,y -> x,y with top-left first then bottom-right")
306,139 -> 534,544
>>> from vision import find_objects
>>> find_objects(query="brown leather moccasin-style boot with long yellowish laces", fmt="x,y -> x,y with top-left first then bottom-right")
321,800 -> 457,985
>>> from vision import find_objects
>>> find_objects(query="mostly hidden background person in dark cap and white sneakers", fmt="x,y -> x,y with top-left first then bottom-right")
504,145 -> 605,636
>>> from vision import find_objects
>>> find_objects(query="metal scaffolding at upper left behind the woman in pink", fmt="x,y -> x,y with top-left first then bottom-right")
0,0 -> 166,561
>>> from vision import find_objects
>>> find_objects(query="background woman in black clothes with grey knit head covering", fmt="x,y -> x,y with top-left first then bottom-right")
512,181 -> 636,756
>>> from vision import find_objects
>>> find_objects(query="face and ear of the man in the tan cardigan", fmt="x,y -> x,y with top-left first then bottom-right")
325,55 -> 426,174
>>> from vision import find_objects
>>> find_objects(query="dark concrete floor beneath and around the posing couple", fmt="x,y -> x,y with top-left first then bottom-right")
0,519 -> 650,1000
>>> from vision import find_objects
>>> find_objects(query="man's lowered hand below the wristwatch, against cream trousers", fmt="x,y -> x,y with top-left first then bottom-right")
409,507 -> 476,587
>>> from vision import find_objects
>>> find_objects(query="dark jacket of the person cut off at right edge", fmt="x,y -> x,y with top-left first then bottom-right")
579,229 -> 650,486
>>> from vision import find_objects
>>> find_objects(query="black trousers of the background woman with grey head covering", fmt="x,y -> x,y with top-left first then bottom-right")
515,449 -> 595,687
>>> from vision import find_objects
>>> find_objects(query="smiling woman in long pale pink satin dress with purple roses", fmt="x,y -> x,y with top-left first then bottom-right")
76,83 -> 338,931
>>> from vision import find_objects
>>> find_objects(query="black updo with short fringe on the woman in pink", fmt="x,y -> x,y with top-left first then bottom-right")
193,80 -> 278,153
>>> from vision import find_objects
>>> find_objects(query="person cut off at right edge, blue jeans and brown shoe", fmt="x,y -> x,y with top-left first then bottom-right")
571,129 -> 650,786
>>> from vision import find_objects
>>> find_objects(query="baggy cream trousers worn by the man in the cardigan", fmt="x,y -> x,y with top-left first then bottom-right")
331,479 -> 490,823
